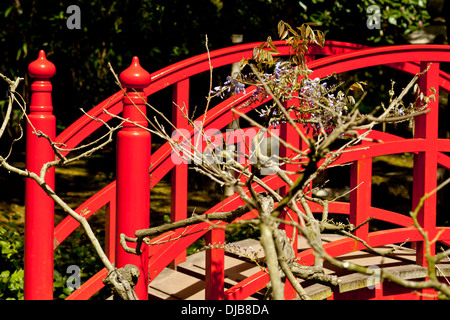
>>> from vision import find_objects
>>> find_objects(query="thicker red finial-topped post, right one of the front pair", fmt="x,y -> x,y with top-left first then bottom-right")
116,57 -> 151,300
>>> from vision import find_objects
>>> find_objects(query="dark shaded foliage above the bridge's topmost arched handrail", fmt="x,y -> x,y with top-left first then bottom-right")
0,0 -> 440,129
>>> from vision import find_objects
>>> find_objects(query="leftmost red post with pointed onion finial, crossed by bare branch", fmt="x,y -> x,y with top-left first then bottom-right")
24,50 -> 56,300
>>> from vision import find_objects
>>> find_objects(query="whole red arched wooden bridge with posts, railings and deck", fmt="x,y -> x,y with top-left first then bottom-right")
25,41 -> 450,299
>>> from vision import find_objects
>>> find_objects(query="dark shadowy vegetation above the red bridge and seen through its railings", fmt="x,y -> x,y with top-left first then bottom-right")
0,0 -> 450,299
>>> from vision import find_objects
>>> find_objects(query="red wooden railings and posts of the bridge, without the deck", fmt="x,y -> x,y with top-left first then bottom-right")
25,42 -> 450,299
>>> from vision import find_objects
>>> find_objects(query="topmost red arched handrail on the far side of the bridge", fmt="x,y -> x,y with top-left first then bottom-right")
57,41 -> 450,154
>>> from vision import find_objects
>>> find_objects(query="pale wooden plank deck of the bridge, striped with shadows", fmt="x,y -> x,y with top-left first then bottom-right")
149,234 -> 450,300
